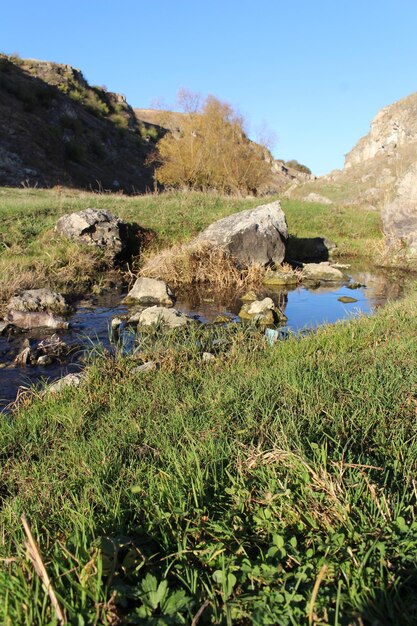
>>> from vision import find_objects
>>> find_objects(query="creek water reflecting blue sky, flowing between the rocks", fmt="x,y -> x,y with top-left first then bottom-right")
0,266 -> 415,411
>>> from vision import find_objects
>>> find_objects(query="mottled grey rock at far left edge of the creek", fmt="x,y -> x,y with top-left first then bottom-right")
6,289 -> 71,329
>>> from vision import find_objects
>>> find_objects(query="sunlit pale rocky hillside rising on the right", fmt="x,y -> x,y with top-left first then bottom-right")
288,93 -> 417,209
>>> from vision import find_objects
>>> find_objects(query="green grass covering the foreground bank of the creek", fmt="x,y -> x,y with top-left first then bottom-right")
0,297 -> 417,626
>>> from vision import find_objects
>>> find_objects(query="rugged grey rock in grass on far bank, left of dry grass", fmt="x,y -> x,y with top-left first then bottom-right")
55,209 -> 128,258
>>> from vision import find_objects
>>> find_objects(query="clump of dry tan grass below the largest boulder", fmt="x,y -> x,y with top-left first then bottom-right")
141,245 -> 266,290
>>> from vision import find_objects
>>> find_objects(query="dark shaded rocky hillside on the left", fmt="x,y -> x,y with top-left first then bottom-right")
0,55 -> 164,193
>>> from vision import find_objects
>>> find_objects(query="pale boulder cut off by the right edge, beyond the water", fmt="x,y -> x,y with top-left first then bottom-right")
382,162 -> 417,257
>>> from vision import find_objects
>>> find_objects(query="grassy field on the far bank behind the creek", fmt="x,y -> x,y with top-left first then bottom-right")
0,188 -> 381,302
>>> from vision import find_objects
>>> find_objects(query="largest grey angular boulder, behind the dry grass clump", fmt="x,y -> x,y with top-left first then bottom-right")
190,200 -> 288,265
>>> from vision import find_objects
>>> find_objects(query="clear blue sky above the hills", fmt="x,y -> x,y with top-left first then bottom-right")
0,0 -> 417,174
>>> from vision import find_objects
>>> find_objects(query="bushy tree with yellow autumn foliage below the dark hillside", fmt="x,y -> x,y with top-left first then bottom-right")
151,94 -> 271,194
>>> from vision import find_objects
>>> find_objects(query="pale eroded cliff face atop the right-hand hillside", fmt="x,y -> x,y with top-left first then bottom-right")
345,93 -> 417,169
